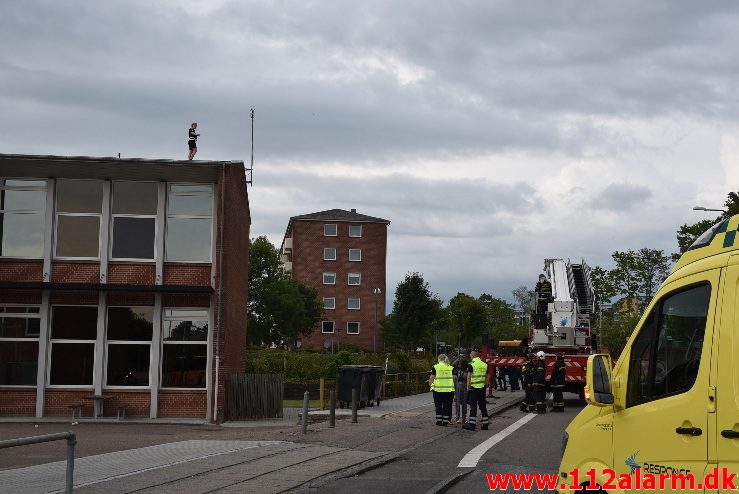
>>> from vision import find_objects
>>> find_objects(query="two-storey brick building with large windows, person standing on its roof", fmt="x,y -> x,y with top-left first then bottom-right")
0,155 -> 251,421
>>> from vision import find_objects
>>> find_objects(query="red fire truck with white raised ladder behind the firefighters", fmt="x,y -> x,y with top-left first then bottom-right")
482,259 -> 596,398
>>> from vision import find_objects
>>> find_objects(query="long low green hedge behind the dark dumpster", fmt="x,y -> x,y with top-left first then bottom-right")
246,349 -> 432,383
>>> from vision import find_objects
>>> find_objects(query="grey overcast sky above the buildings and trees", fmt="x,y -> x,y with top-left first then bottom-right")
0,0 -> 739,309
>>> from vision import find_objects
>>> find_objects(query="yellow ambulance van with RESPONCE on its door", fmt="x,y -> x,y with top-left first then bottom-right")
559,215 -> 739,492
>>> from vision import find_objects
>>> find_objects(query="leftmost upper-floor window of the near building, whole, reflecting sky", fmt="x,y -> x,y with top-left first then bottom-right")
0,178 -> 46,258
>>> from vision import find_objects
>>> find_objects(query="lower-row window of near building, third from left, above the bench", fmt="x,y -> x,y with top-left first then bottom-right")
105,307 -> 154,386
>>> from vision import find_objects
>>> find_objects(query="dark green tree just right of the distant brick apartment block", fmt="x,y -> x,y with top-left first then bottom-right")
383,273 -> 441,349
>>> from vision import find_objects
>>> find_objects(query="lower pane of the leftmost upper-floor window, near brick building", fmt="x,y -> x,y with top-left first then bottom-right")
0,213 -> 44,257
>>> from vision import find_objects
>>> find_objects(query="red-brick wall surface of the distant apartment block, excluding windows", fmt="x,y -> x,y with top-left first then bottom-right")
292,221 -> 387,350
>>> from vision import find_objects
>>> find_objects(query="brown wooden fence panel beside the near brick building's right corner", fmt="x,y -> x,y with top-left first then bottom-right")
226,374 -> 284,420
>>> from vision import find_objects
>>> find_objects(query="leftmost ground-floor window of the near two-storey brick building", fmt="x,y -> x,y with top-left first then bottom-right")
0,306 -> 41,386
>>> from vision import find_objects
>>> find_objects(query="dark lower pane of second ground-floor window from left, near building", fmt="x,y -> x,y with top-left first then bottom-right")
49,343 -> 95,386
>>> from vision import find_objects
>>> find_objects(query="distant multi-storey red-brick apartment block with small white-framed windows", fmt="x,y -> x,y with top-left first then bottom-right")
281,209 -> 390,351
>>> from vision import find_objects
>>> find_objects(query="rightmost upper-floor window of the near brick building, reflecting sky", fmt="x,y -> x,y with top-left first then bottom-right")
166,184 -> 213,262
